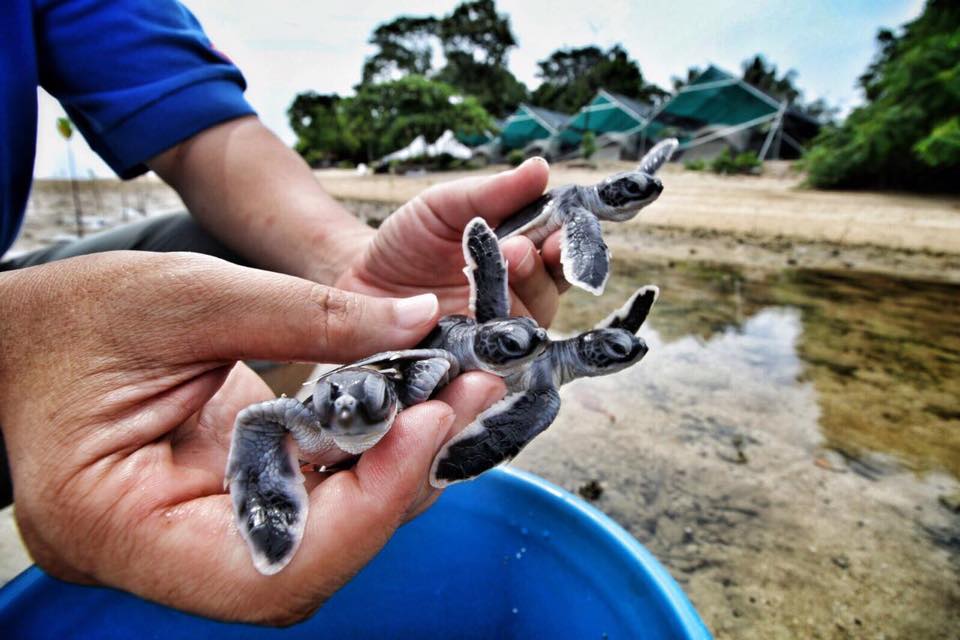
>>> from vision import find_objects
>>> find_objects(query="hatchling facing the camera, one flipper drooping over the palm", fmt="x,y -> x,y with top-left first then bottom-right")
224,349 -> 458,575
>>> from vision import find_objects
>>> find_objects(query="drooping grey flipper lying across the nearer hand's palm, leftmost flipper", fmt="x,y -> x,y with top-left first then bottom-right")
224,398 -> 315,575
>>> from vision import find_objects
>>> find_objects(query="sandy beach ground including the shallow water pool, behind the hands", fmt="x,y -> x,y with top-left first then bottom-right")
0,164 -> 960,639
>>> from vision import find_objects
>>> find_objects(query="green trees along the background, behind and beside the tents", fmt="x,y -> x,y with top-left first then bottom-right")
288,0 -> 960,190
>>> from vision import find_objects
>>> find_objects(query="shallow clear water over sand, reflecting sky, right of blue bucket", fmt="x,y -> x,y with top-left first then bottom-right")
532,258 -> 960,638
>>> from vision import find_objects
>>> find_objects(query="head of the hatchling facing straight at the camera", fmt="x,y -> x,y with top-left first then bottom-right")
313,369 -> 397,454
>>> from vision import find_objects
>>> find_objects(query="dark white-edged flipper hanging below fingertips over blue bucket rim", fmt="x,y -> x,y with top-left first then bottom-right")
430,388 -> 560,489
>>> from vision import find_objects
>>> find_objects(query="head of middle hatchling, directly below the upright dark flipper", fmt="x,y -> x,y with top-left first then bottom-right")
473,318 -> 548,375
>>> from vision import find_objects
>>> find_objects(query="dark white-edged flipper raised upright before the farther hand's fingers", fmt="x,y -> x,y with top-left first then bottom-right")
463,218 -> 510,322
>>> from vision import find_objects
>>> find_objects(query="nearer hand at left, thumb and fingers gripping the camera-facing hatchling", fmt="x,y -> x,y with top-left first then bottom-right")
0,252 -> 503,624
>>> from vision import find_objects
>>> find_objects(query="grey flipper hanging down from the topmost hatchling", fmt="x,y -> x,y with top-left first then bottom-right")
560,208 -> 610,296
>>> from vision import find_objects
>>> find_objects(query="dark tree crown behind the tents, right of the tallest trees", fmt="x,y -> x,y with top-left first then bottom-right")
531,45 -> 667,113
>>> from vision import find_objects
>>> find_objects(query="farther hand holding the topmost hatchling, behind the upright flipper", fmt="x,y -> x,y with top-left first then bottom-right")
336,158 -> 562,327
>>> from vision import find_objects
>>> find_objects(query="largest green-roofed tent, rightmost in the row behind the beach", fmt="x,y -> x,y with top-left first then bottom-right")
640,65 -> 819,159
